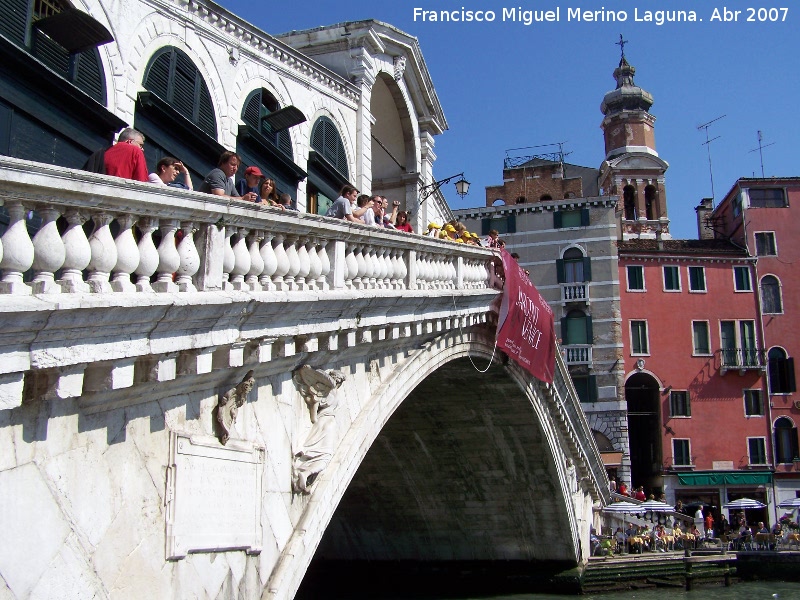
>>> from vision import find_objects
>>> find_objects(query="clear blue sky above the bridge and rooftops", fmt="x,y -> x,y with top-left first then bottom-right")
221,0 -> 800,238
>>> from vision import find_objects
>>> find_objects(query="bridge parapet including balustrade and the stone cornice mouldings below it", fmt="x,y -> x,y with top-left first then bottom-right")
0,157 -> 496,409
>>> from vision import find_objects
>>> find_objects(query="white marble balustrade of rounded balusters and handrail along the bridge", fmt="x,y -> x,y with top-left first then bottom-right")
0,157 -> 490,295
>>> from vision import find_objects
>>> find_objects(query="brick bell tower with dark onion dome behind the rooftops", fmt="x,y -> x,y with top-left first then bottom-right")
600,35 -> 671,240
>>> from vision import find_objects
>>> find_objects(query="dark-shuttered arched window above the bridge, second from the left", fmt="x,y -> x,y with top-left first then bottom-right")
144,46 -> 217,139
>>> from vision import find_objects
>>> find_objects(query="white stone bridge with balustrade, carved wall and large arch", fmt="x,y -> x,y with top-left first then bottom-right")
0,157 -> 608,598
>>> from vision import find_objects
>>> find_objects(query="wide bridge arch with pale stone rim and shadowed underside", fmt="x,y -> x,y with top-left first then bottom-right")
263,326 -> 592,598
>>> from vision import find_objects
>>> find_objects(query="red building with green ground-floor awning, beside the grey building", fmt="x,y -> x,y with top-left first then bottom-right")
618,239 -> 772,518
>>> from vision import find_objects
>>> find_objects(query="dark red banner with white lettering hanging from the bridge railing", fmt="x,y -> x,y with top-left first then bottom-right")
497,250 -> 556,383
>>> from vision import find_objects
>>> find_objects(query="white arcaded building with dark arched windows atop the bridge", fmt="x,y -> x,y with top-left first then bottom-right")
0,0 -> 449,229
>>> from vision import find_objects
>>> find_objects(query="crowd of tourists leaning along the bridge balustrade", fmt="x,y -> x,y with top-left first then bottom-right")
84,128 -> 505,249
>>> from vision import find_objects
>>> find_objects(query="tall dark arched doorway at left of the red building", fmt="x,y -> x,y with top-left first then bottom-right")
625,373 -> 662,493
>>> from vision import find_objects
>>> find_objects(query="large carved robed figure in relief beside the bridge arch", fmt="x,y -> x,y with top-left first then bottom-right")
292,365 -> 345,494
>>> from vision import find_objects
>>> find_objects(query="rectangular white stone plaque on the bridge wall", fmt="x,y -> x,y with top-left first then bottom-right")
166,432 -> 265,559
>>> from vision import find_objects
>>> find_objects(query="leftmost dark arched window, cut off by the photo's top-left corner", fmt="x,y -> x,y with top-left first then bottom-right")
0,0 -> 108,105
